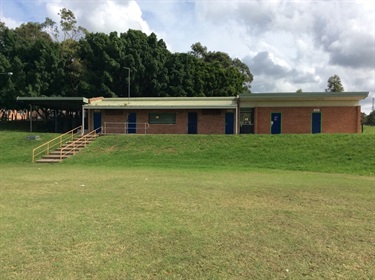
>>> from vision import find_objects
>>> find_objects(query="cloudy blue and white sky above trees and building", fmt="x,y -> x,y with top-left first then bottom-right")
0,0 -> 375,114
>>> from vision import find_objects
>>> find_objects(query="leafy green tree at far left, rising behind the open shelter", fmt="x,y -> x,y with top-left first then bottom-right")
0,23 -> 60,103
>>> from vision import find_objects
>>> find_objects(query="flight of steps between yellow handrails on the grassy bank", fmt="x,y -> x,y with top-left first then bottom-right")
35,134 -> 99,163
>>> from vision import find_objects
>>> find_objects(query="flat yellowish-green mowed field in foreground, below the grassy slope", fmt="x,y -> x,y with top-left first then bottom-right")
0,165 -> 375,279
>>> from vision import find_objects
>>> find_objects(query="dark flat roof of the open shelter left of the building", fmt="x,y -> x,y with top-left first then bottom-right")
17,97 -> 89,110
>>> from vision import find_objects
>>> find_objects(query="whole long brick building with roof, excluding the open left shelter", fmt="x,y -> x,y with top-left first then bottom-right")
83,92 -> 368,134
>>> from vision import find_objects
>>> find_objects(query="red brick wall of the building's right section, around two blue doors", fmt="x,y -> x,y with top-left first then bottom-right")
254,107 -> 360,134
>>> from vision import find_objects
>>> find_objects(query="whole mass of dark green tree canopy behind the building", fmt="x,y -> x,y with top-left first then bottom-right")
0,8 -> 253,109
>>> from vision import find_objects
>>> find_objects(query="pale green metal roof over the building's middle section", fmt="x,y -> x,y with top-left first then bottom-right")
84,97 -> 237,110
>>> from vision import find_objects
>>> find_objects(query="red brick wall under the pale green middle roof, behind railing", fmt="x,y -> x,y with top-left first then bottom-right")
89,110 -> 226,134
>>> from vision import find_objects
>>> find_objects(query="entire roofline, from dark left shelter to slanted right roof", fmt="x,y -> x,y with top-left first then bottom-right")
17,92 -> 369,110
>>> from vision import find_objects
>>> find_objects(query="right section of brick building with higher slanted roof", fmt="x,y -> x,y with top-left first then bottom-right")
239,92 -> 368,134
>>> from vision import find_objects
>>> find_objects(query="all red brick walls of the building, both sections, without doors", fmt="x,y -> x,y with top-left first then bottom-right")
88,106 -> 361,134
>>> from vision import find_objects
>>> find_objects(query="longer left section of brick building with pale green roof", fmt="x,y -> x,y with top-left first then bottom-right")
84,97 -> 238,134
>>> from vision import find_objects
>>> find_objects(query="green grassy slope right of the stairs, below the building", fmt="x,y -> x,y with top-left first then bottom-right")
67,134 -> 375,175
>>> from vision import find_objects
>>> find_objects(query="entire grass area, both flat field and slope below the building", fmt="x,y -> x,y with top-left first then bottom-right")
0,128 -> 375,279
